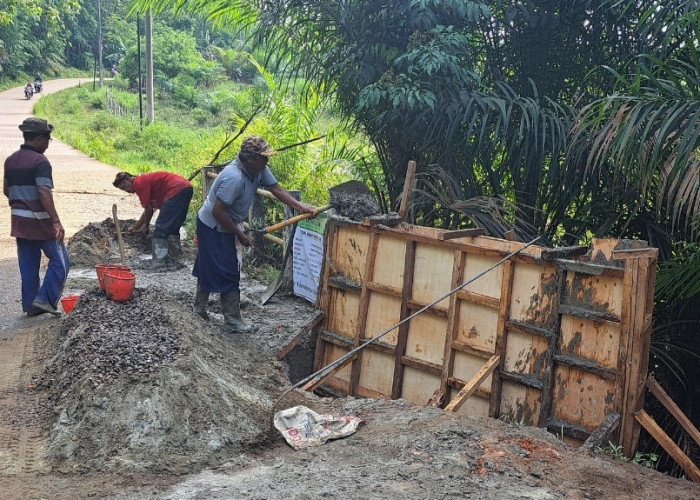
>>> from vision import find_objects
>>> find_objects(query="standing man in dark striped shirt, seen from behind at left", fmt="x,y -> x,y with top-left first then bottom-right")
3,117 -> 69,316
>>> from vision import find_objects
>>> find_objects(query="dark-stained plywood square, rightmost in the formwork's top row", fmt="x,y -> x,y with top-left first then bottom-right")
565,271 -> 623,316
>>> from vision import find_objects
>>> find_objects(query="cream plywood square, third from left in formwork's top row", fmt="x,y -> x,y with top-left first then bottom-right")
411,244 -> 454,308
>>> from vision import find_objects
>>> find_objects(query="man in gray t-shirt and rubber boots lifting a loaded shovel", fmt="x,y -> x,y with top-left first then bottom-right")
192,135 -> 316,333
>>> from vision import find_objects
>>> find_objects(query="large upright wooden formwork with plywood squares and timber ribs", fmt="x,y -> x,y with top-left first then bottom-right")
315,222 -> 657,451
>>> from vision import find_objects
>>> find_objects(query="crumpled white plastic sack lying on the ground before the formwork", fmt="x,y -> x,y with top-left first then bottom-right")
275,406 -> 362,450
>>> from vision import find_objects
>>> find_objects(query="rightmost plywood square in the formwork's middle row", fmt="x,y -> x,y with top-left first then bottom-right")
559,316 -> 620,370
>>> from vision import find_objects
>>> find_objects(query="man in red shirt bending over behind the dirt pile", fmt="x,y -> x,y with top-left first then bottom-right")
113,172 -> 192,271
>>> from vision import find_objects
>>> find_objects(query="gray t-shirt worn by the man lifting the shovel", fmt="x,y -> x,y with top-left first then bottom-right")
197,157 -> 277,233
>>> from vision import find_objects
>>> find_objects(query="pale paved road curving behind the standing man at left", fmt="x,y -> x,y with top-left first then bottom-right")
0,78 -> 142,328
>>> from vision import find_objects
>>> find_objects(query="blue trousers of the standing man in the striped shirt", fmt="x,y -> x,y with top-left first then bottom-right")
17,238 -> 69,312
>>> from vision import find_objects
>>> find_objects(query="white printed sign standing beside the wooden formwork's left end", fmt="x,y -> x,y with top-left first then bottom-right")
293,214 -> 328,303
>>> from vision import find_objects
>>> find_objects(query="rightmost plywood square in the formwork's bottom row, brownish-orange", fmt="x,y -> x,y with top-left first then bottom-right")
552,365 -> 615,432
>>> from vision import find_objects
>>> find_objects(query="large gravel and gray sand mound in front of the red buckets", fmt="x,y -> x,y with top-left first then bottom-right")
41,290 -> 288,474
